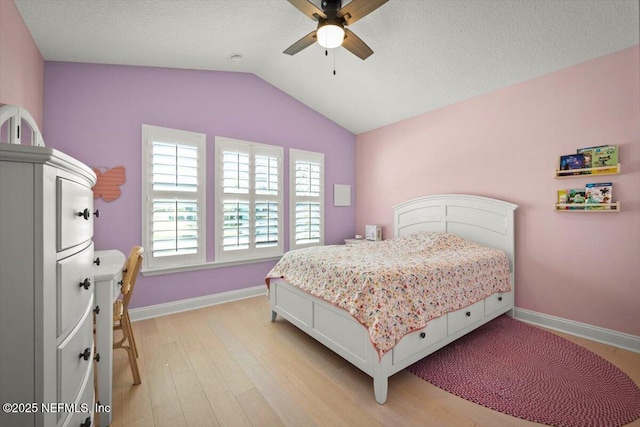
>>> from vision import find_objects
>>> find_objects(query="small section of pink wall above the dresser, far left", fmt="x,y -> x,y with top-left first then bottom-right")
0,0 -> 44,127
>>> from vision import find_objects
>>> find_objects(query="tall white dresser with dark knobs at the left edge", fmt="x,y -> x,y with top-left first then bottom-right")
0,144 -> 96,427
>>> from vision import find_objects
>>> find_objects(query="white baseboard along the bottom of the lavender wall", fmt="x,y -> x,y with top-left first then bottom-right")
129,285 -> 267,322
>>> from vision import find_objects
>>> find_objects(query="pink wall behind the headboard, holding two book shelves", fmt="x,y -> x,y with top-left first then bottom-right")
356,46 -> 640,336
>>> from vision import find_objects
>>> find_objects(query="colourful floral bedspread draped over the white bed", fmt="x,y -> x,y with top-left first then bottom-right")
266,232 -> 511,357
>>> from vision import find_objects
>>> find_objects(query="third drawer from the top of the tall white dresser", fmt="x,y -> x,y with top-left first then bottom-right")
58,300 -> 94,412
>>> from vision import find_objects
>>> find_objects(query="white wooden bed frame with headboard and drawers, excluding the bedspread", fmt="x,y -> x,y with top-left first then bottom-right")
270,194 -> 517,404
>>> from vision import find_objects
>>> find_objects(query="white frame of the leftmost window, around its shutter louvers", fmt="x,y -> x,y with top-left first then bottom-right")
141,124 -> 207,272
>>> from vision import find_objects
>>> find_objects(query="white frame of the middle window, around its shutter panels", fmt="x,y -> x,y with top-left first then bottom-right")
214,136 -> 285,263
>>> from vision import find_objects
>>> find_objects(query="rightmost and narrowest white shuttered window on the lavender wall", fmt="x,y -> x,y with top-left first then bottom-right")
289,149 -> 324,250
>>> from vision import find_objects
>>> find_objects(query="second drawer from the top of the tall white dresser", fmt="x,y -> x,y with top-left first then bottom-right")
57,243 -> 94,336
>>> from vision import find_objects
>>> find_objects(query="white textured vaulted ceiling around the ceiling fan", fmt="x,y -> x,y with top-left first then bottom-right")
13,0 -> 640,134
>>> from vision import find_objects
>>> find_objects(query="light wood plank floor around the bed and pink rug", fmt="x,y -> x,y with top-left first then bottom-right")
112,297 -> 640,427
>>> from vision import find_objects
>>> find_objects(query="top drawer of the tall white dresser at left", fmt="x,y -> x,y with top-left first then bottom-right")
56,178 -> 93,251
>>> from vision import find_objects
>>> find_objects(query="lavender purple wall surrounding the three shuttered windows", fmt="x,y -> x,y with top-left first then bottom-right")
44,62 -> 355,307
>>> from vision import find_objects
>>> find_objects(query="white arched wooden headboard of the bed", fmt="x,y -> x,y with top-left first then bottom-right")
393,194 -> 518,283
